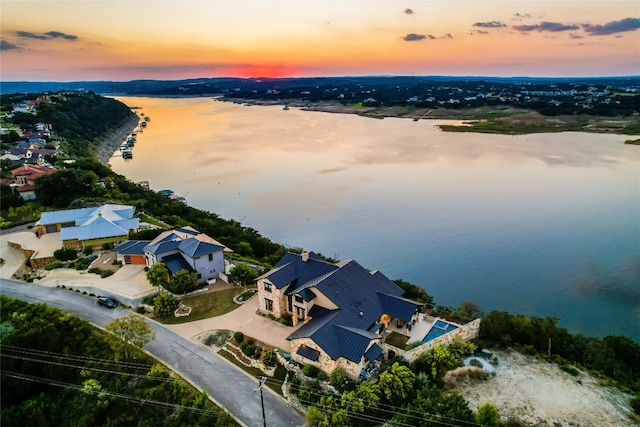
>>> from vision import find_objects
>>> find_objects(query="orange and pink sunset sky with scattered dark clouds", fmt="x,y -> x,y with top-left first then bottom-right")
0,0 -> 640,81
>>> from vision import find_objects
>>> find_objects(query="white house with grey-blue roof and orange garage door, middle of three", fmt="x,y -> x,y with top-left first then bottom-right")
114,226 -> 233,282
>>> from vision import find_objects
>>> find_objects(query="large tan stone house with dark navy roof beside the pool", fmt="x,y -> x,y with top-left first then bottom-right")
257,252 -> 421,379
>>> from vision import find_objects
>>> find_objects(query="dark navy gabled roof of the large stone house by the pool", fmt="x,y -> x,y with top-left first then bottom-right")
282,254 -> 420,363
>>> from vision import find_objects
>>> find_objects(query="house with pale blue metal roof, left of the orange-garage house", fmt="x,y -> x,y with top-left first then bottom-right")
36,204 -> 140,249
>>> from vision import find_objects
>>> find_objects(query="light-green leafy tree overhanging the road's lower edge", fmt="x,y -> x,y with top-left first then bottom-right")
104,314 -> 156,360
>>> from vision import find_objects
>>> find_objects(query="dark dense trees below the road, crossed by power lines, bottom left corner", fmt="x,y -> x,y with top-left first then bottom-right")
0,296 -> 236,427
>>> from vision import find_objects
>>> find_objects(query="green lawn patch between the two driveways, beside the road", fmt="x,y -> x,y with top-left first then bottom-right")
155,288 -> 245,324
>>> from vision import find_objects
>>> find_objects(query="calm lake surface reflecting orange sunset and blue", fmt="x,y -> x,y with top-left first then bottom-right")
111,97 -> 640,342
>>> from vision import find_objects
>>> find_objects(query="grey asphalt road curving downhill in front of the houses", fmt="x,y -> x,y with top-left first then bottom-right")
0,279 -> 304,427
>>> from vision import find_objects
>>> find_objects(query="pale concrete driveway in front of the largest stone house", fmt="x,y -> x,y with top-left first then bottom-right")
166,295 -> 296,351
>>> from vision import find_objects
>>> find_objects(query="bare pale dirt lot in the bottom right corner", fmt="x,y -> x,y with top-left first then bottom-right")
456,352 -> 640,426
